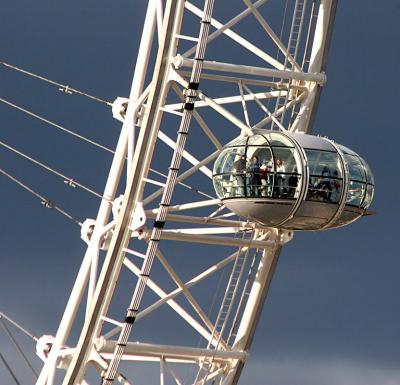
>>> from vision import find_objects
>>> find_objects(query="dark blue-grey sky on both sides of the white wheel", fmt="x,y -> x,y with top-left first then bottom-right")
0,0 -> 400,385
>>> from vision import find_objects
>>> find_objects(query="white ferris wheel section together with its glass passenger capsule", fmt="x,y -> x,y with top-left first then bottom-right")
0,0 -> 374,385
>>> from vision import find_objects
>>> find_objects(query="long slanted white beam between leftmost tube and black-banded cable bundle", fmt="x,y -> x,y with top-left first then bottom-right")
63,1 -> 188,385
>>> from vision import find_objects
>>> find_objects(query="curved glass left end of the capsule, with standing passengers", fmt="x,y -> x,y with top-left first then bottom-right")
213,133 -> 301,199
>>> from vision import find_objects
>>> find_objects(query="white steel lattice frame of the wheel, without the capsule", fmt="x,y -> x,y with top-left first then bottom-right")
37,0 -> 336,385
